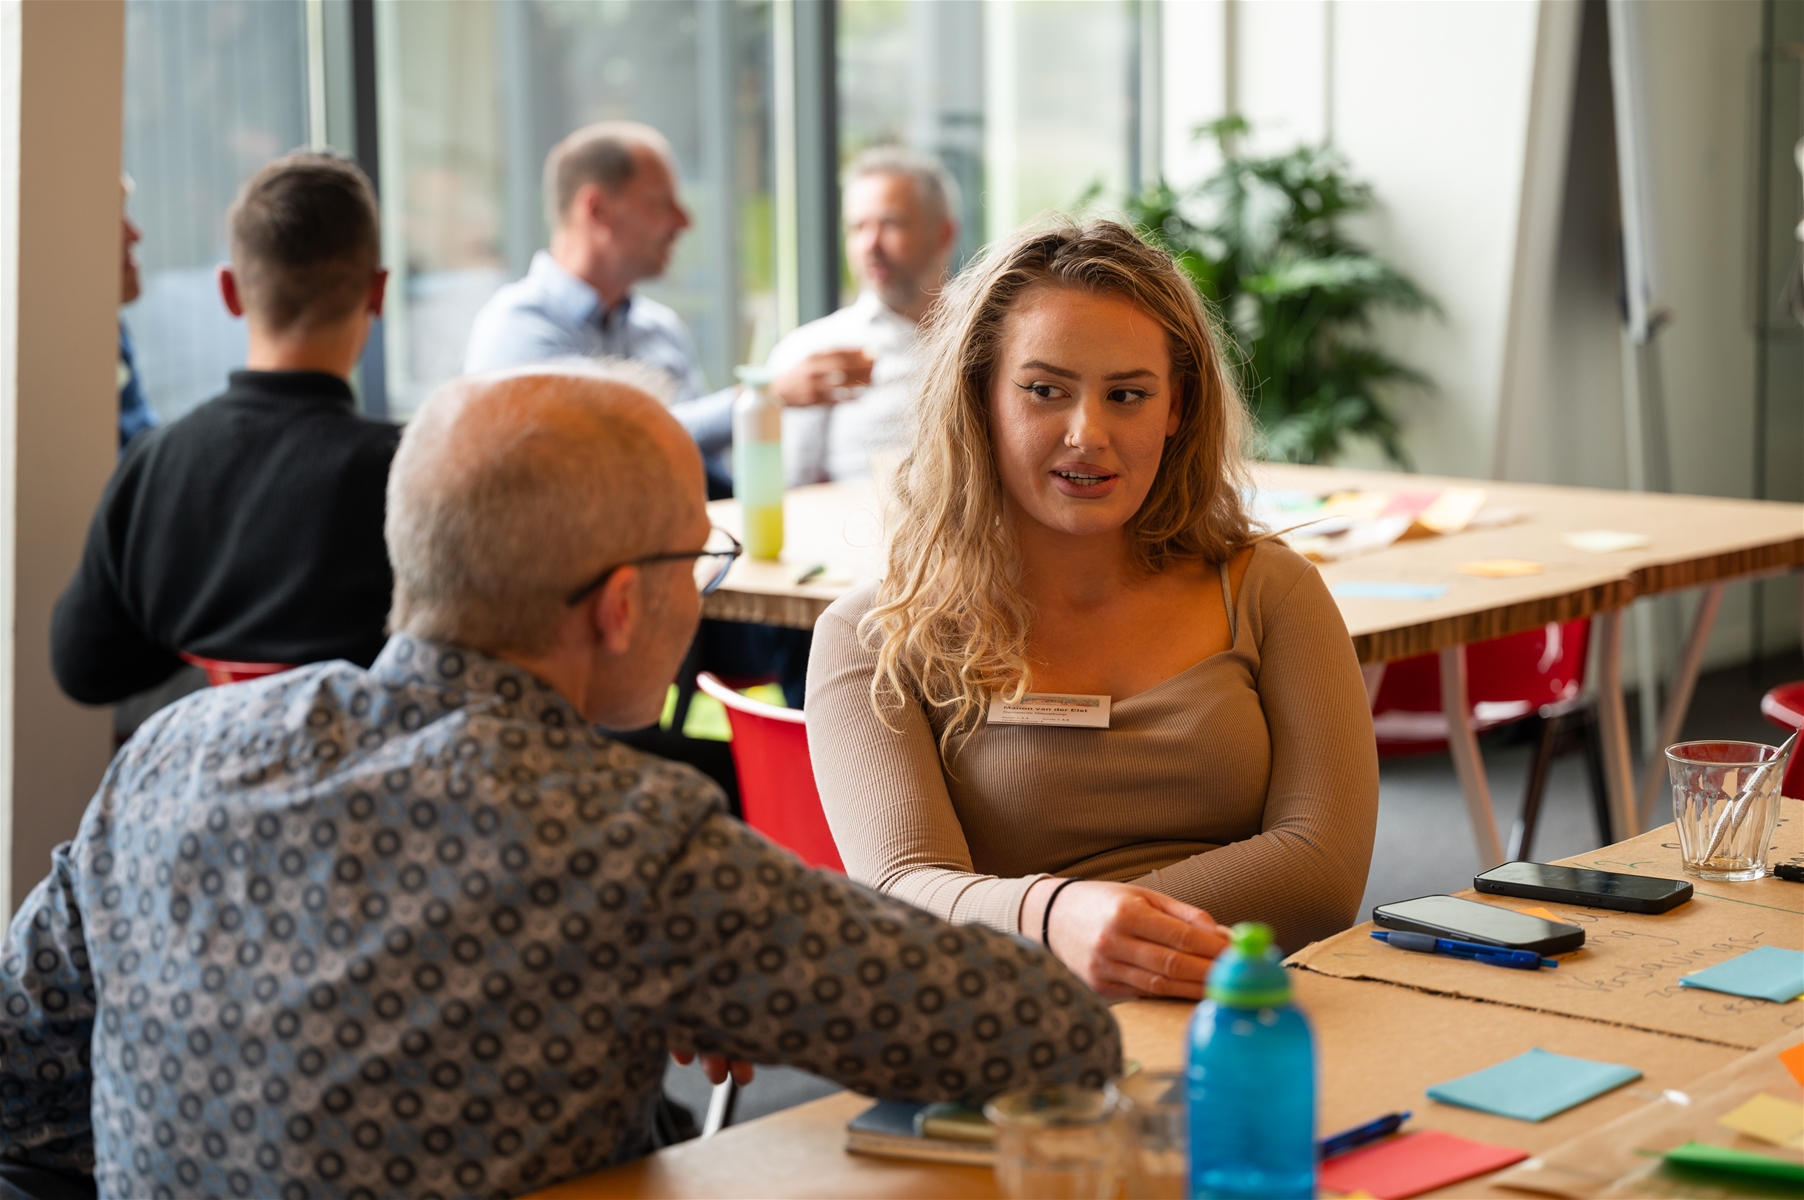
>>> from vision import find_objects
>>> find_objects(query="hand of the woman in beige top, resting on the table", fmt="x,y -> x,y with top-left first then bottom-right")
1021,879 -> 1229,1000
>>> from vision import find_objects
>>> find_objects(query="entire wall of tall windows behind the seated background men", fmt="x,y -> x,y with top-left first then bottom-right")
124,0 -> 1149,419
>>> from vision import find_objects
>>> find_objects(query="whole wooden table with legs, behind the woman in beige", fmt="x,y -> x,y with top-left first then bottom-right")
704,464 -> 1804,866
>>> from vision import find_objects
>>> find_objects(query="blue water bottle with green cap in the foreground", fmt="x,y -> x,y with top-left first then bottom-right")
1189,924 -> 1315,1200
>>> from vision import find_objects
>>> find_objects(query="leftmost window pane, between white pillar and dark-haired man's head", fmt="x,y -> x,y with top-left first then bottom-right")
124,0 -> 308,420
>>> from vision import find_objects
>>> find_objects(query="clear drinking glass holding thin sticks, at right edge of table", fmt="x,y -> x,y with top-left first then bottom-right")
1667,742 -> 1781,882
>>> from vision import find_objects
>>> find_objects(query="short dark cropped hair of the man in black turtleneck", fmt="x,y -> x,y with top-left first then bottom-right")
226,150 -> 382,334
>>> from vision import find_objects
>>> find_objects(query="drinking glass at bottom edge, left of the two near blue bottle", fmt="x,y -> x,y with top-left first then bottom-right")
983,1085 -> 1120,1200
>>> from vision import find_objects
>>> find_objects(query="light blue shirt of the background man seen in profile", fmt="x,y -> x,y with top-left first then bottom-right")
464,251 -> 734,455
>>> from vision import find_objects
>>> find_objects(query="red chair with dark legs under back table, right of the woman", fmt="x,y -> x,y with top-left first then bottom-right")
1371,619 -> 1611,859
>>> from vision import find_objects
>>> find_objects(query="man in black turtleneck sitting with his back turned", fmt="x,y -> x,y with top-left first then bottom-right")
51,153 -> 400,704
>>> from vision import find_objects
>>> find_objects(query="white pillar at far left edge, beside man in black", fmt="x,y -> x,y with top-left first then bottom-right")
0,0 -> 124,906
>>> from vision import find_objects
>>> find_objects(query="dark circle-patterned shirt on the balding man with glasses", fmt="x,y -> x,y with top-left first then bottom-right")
0,633 -> 1120,1200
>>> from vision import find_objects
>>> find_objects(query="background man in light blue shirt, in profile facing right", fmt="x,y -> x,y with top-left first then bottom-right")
464,121 -> 840,500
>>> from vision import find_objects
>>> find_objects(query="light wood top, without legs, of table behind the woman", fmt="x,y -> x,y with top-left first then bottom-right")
704,464 -> 1804,662
